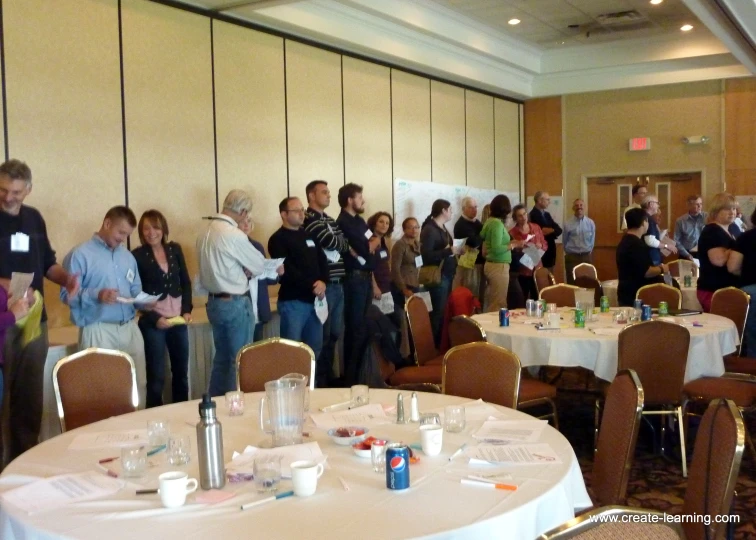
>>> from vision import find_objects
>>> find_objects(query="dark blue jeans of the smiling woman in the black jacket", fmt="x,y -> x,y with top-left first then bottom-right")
139,318 -> 189,408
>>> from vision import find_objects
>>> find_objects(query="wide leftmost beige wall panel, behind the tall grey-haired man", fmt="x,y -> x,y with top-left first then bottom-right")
3,0 -> 124,326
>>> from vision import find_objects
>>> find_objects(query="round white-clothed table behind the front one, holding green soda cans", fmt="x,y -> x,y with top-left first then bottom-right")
473,308 -> 738,382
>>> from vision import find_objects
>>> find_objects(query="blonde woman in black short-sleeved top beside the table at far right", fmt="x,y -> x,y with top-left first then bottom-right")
696,193 -> 737,313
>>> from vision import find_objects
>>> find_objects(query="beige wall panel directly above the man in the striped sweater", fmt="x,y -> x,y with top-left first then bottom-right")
286,41 -> 344,200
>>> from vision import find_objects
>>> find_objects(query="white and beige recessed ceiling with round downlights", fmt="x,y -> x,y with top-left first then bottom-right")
168,0 -> 756,99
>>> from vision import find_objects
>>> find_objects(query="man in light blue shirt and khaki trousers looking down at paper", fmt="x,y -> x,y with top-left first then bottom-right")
60,206 -> 147,408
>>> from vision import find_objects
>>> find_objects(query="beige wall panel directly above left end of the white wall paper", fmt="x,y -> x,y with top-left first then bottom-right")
391,69 -> 431,181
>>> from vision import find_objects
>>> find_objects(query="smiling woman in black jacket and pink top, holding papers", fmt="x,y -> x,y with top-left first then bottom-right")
132,210 -> 192,407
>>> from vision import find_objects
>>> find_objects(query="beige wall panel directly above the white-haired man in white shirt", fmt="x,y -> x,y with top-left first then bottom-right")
213,21 -> 288,250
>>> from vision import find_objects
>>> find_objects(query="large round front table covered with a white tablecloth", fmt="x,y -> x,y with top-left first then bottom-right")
0,389 -> 591,540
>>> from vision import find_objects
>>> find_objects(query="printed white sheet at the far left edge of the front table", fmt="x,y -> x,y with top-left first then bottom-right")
2,471 -> 126,514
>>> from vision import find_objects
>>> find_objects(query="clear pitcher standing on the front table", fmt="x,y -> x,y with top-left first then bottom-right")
260,378 -> 306,447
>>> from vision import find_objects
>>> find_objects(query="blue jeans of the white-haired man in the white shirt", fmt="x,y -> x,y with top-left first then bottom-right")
207,295 -> 254,397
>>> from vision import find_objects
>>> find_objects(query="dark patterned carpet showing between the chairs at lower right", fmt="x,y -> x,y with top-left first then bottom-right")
550,370 -> 756,540
